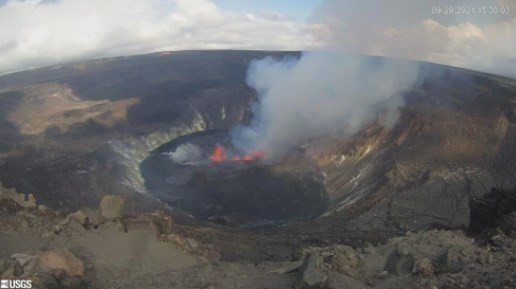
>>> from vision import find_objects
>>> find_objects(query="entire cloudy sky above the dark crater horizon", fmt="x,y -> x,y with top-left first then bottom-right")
0,0 -> 516,78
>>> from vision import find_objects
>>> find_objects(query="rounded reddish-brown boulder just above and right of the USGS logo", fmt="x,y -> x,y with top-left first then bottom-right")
40,249 -> 84,276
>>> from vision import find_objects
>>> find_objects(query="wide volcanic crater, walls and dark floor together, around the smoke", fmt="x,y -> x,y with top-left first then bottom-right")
0,51 -> 516,236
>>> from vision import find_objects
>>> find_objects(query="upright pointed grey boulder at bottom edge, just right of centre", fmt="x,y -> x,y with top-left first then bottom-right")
300,251 -> 328,289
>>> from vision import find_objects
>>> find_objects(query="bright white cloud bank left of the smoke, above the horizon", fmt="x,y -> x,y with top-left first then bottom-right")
0,0 -> 316,74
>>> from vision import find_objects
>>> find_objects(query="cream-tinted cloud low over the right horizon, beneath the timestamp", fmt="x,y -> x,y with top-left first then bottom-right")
376,19 -> 516,77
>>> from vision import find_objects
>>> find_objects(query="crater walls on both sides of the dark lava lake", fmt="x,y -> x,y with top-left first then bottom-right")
0,51 -> 516,232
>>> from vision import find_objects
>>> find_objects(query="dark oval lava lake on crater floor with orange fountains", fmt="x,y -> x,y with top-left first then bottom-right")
141,130 -> 327,226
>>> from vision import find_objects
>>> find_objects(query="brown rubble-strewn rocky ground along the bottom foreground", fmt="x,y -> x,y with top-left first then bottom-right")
0,194 -> 516,289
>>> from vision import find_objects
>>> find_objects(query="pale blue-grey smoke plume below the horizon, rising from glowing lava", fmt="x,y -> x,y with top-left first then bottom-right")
232,52 -> 419,160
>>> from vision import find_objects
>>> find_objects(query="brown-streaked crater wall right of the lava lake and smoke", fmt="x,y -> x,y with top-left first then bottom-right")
312,65 -> 516,230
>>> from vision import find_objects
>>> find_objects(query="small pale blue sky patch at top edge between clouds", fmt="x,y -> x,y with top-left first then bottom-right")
215,0 -> 321,20
